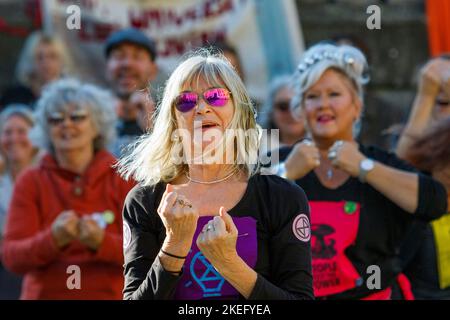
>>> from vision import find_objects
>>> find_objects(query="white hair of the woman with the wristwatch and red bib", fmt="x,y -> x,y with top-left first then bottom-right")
291,43 -> 369,136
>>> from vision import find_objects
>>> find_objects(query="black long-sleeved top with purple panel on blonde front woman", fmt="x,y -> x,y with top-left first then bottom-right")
123,174 -> 313,300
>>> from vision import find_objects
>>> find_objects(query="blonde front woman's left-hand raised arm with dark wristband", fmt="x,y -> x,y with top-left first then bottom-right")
123,185 -> 198,300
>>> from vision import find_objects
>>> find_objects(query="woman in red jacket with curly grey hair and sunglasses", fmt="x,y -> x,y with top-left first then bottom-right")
3,79 -> 133,299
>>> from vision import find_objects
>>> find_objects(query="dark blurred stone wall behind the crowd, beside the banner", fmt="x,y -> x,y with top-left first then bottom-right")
0,0 -> 429,147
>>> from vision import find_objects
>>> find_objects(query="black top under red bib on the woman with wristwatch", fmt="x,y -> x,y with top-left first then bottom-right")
272,145 -> 447,299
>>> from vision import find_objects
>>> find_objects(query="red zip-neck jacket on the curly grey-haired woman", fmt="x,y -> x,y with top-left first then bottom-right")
3,151 -> 134,299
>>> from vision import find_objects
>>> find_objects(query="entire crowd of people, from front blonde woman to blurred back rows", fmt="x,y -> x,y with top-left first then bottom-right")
0,28 -> 450,300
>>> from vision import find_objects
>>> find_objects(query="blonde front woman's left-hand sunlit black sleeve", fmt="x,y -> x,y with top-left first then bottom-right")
123,186 -> 181,300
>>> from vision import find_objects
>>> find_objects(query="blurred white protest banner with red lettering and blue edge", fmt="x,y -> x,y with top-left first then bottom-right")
42,0 -> 303,101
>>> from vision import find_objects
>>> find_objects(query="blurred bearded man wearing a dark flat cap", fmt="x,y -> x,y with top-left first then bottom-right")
105,28 -> 158,156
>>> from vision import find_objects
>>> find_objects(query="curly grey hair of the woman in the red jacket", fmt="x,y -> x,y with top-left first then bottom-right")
30,78 -> 117,152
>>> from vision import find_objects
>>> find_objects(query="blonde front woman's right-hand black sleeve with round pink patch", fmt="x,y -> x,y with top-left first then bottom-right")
249,177 -> 314,300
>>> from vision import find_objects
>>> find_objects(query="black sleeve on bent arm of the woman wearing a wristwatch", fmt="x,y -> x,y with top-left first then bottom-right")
364,147 -> 447,221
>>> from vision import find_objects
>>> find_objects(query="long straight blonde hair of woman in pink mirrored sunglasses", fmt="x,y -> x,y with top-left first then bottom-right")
117,49 -> 261,185
